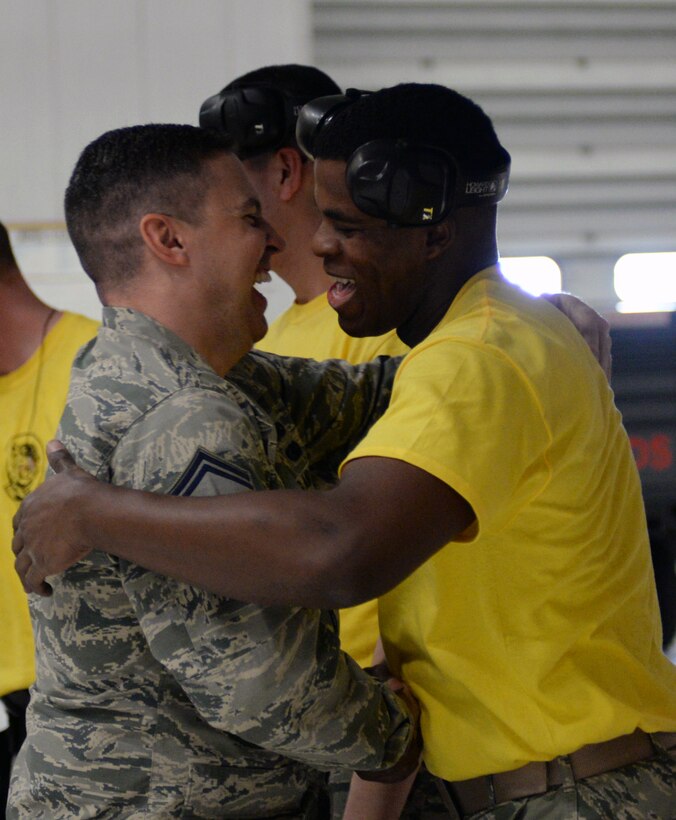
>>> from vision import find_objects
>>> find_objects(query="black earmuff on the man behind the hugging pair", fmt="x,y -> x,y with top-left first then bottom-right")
199,84 -> 307,159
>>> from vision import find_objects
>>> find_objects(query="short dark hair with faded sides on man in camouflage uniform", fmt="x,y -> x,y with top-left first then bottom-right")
64,124 -> 230,288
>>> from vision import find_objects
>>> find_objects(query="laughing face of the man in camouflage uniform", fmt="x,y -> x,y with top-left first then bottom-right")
185,155 -> 284,355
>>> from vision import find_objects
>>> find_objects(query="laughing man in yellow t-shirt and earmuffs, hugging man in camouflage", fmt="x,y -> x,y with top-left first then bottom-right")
15,84 -> 676,818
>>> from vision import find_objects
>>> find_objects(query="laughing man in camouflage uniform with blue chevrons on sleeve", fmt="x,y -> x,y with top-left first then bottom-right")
9,125 -> 417,820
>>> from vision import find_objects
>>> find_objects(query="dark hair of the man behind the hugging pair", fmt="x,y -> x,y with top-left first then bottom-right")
223,63 -> 342,162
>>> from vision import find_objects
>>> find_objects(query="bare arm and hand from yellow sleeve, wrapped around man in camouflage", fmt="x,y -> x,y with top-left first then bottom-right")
13,451 -> 474,608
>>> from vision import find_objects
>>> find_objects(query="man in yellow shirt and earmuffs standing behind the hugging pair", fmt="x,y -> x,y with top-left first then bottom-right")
200,64 -> 604,680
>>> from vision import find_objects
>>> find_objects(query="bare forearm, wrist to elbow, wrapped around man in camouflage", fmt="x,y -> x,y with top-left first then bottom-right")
81,483 -> 370,608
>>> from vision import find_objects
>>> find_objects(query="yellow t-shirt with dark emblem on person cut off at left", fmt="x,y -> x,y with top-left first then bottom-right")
0,313 -> 98,695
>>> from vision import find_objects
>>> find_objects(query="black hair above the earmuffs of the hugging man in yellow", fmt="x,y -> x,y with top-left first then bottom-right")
313,83 -> 505,176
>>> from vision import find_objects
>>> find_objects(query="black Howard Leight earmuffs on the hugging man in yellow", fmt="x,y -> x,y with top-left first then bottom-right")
296,89 -> 510,227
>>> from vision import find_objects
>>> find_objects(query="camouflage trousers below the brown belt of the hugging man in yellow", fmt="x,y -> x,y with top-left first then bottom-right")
331,749 -> 676,820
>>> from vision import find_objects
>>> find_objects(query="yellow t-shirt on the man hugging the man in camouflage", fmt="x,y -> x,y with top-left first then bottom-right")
349,268 -> 676,780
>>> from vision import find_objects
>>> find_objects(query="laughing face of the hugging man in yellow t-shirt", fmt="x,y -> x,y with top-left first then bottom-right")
312,160 -> 436,343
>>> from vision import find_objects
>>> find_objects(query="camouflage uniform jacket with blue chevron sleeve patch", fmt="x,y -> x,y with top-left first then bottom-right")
9,308 -> 410,820
